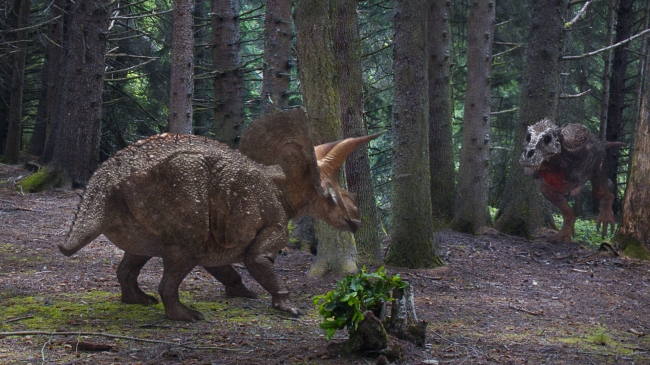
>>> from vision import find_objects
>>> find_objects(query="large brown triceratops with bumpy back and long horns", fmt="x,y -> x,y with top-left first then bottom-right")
59,108 -> 377,321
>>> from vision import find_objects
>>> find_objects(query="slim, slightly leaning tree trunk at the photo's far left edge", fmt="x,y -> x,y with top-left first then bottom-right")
3,0 -> 31,164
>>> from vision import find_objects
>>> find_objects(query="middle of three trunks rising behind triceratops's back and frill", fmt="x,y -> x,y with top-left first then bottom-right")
212,0 -> 244,147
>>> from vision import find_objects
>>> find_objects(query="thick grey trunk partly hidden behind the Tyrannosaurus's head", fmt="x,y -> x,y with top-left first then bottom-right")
496,0 -> 568,238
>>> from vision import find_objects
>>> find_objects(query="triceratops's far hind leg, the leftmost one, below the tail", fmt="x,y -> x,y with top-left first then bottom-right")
117,252 -> 158,304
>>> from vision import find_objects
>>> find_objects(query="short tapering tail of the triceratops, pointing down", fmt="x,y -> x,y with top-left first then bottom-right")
59,186 -> 104,256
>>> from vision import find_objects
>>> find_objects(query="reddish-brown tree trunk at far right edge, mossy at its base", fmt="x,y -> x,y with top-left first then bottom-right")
612,42 -> 650,259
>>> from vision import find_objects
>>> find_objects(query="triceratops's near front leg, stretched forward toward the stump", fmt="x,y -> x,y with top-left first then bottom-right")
244,225 -> 302,316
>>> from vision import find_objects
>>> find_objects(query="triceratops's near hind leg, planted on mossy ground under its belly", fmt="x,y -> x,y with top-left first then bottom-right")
158,255 -> 203,322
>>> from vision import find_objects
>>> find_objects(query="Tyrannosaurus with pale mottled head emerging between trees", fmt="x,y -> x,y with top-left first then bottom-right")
519,119 -> 625,242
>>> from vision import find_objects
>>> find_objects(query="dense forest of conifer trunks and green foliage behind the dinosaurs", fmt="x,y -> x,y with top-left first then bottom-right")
0,0 -> 650,271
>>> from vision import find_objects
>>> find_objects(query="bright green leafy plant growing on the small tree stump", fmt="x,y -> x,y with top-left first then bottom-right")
314,266 -> 408,340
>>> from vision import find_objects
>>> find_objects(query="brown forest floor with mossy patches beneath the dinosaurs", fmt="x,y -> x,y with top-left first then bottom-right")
0,165 -> 650,364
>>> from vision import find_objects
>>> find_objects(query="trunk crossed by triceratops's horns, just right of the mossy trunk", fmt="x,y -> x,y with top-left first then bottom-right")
331,0 -> 382,263
